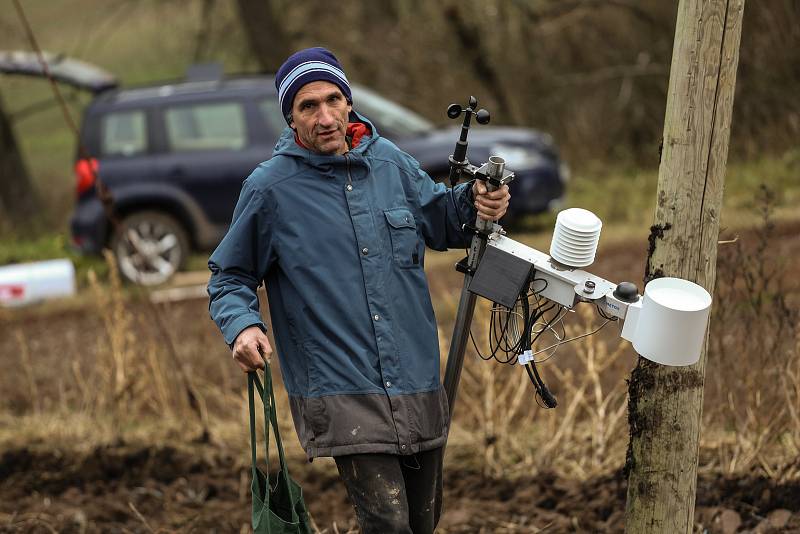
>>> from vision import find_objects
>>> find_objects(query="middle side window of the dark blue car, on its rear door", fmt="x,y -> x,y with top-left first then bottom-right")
164,102 -> 247,151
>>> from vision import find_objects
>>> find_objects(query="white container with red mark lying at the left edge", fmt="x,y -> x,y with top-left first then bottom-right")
0,259 -> 75,306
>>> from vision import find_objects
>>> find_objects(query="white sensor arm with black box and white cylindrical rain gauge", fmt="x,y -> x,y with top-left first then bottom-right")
469,233 -> 712,365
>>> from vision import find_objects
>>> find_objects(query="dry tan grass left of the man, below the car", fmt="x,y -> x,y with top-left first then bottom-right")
0,253 -> 304,466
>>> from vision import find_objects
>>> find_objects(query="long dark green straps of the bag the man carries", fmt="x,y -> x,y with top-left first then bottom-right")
247,362 -> 299,521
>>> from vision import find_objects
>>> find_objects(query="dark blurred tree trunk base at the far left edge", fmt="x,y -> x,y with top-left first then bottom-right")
0,94 -> 39,230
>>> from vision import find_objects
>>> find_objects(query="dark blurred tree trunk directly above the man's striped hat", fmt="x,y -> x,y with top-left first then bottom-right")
237,0 -> 294,72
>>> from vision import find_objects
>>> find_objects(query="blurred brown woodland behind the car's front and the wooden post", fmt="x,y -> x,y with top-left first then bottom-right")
223,0 -> 800,164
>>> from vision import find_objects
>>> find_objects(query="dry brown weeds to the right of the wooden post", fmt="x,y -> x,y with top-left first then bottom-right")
704,186 -> 800,478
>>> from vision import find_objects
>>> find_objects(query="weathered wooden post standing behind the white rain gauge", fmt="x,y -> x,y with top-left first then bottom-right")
625,0 -> 744,534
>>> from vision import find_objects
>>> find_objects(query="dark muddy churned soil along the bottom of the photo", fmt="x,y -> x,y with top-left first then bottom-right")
0,445 -> 800,533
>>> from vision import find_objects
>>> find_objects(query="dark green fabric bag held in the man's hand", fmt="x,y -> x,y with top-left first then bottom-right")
247,363 -> 311,534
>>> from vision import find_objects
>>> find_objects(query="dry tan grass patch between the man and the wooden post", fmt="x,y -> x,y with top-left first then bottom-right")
451,306 -> 631,479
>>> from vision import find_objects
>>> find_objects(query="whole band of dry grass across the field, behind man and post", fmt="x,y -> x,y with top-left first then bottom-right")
0,193 -> 800,498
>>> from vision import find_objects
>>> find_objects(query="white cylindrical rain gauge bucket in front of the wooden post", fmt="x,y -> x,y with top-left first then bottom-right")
622,278 -> 711,365
